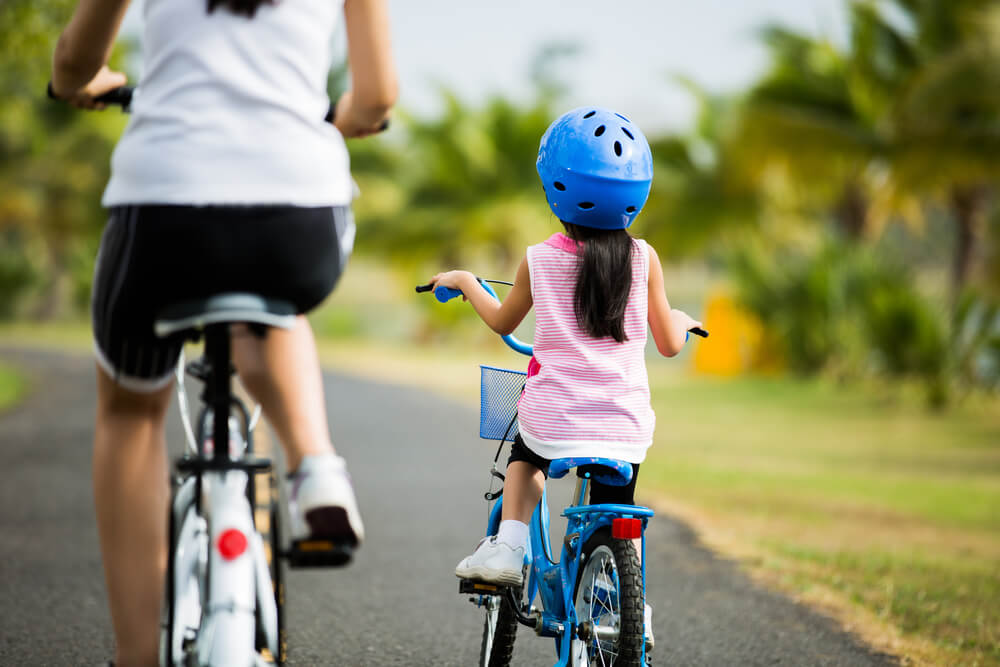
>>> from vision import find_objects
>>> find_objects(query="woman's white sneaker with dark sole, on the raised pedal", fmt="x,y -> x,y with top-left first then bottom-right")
288,453 -> 365,547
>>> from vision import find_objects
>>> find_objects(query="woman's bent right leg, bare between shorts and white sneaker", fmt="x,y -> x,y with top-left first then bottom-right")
233,316 -> 333,471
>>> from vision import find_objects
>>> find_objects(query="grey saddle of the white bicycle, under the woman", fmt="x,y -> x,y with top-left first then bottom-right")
153,292 -> 296,338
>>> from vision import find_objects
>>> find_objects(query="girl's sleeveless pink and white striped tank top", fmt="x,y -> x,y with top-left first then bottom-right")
518,234 -> 656,463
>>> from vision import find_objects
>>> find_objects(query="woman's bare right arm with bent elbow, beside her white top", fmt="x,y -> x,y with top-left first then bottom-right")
333,0 -> 398,137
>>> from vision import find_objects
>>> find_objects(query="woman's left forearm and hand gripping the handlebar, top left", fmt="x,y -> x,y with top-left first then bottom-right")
52,0 -> 129,109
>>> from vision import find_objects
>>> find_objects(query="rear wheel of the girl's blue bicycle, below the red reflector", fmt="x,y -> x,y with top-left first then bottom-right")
571,528 -> 645,667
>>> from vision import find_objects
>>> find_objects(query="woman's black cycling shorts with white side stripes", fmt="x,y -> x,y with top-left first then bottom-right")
91,205 -> 354,392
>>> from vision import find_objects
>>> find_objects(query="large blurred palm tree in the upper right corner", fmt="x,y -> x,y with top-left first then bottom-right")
739,0 -> 1000,294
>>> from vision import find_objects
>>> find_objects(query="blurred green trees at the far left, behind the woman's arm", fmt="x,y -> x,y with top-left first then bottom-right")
0,0 -> 127,317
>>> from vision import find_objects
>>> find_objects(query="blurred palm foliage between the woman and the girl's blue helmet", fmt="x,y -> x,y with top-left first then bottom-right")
352,91 -> 551,268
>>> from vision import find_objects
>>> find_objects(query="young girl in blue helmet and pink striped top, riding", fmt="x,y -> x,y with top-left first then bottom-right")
431,107 -> 700,585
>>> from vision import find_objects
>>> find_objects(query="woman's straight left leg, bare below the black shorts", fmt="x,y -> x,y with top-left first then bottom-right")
93,367 -> 171,667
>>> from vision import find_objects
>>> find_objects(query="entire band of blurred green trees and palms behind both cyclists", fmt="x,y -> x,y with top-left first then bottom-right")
0,0 -> 1000,407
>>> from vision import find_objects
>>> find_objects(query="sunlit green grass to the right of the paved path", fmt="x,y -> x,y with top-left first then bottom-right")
640,370 -> 1000,665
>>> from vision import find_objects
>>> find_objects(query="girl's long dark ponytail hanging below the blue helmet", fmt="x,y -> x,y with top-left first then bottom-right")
563,222 -> 632,343
